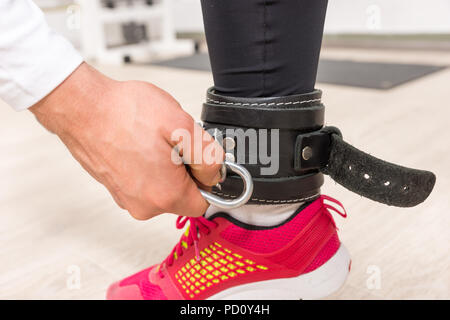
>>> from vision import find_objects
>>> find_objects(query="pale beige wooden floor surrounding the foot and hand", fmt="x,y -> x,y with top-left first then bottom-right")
0,49 -> 450,299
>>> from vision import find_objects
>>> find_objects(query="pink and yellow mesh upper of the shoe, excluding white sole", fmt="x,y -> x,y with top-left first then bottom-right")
108,196 -> 340,300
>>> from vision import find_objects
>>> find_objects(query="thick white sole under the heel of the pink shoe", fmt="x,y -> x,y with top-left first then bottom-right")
208,244 -> 351,300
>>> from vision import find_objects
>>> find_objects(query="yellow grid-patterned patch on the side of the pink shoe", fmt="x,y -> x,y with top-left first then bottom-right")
175,242 -> 268,299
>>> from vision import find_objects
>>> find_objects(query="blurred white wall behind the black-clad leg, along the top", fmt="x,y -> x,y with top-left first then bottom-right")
170,0 -> 450,33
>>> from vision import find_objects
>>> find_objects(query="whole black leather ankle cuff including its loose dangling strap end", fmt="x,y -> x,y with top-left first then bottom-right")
202,89 -> 436,207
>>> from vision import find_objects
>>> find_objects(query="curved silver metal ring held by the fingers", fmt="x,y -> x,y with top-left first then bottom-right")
200,161 -> 253,209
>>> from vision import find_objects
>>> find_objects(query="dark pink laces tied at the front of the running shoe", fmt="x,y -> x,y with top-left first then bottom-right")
158,217 -> 217,278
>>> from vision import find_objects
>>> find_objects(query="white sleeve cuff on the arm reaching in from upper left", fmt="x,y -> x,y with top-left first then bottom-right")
0,0 -> 83,110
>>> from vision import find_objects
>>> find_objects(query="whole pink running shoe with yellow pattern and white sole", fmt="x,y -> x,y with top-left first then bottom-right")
107,195 -> 350,300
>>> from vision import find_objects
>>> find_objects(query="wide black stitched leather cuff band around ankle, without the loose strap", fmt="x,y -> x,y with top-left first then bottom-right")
202,88 -> 325,204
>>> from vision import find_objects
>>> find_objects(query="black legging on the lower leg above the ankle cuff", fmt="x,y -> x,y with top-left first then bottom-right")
201,0 -> 328,97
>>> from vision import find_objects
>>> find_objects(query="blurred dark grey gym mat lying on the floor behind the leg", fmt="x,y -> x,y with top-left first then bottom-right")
152,54 -> 446,90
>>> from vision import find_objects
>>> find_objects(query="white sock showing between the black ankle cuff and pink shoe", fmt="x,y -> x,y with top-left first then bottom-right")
205,203 -> 303,227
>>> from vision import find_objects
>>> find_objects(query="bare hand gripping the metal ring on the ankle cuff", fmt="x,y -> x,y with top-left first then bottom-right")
30,63 -> 224,220
